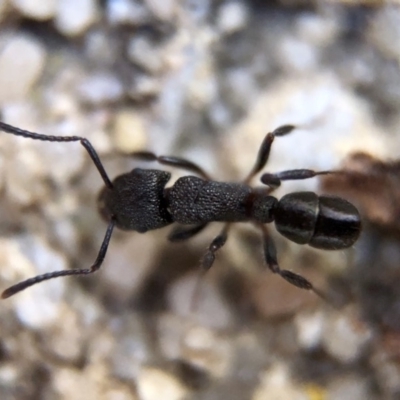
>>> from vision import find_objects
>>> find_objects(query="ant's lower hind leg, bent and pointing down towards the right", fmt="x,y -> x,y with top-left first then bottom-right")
261,225 -> 323,297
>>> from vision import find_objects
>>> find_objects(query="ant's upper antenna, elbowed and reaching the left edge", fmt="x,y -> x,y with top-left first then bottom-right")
0,122 -> 113,189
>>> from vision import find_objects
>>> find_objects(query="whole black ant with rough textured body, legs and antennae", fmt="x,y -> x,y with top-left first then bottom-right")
0,122 -> 361,299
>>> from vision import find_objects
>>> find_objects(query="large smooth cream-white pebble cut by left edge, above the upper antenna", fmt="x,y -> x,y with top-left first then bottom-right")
0,35 -> 46,104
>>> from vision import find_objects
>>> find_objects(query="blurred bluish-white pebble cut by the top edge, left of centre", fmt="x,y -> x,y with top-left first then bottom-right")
55,0 -> 99,36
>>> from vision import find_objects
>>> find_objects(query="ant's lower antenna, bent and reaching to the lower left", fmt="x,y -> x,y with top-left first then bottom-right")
1,218 -> 116,299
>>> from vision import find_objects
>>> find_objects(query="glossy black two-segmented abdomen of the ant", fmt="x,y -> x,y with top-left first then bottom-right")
274,192 -> 361,250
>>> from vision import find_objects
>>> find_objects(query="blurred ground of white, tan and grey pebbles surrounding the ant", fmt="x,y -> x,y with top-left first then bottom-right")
0,0 -> 400,400
